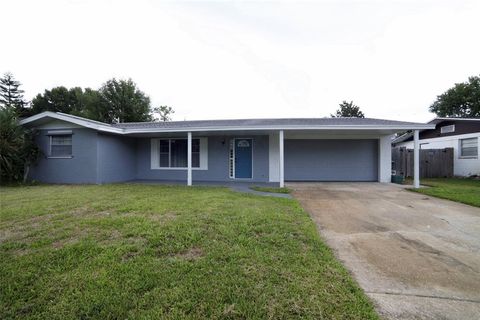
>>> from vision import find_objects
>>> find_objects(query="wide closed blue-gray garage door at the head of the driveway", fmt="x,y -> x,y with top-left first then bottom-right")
285,139 -> 378,181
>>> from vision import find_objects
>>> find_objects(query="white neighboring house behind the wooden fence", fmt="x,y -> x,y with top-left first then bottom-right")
392,118 -> 480,177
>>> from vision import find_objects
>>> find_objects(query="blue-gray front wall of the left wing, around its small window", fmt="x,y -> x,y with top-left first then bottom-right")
29,129 -> 97,183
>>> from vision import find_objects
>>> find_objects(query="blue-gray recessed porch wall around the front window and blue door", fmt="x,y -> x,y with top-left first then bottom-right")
137,136 -> 268,183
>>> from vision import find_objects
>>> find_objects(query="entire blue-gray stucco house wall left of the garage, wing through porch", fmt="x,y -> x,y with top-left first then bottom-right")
29,129 -> 269,183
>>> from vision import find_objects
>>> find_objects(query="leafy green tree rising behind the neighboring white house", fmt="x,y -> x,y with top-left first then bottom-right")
430,76 -> 480,118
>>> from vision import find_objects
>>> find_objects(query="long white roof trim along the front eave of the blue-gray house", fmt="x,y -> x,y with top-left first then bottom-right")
20,111 -> 435,135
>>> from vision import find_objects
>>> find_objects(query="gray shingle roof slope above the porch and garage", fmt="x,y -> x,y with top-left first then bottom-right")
112,118 -> 428,129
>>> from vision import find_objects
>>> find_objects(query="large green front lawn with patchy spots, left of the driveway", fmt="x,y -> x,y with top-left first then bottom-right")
0,184 -> 378,319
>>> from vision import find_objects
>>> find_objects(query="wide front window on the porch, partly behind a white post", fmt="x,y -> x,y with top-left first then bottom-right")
158,139 -> 200,168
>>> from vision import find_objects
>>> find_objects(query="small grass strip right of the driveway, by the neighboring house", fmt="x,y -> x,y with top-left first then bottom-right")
410,178 -> 480,207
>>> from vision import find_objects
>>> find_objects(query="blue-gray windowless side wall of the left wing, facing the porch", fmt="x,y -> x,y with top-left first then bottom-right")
97,134 -> 137,183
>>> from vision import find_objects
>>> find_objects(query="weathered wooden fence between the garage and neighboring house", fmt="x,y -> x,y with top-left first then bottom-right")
392,147 -> 453,178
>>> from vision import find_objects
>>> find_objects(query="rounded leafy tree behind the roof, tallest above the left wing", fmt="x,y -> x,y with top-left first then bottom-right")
99,78 -> 152,123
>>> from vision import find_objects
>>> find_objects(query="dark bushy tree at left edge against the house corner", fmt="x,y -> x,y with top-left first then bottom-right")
0,108 -> 40,182
